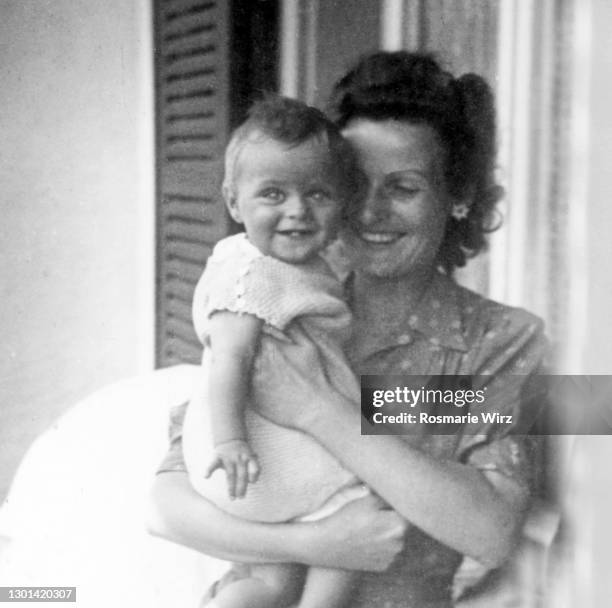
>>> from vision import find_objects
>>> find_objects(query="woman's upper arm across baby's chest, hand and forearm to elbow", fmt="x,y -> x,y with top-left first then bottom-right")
256,338 -> 528,566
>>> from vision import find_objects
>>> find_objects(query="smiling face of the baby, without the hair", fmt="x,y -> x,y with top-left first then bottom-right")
228,138 -> 342,264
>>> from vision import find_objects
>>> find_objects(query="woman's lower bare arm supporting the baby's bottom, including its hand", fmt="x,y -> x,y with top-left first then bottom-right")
148,472 -> 406,571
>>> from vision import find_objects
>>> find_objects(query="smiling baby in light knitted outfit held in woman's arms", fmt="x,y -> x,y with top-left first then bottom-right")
184,97 -> 368,608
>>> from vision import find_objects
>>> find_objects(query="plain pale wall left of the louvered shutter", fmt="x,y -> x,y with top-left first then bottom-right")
0,0 -> 154,499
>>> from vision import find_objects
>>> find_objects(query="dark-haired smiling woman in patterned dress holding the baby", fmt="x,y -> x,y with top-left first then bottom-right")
147,52 -> 545,608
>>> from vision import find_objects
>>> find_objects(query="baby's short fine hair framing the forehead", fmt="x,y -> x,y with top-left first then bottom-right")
223,94 -> 359,204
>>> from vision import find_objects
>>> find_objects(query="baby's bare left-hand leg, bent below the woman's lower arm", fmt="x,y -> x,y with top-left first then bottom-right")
206,564 -> 305,608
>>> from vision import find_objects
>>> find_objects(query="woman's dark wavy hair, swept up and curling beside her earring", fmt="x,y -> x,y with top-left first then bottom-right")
328,51 -> 504,274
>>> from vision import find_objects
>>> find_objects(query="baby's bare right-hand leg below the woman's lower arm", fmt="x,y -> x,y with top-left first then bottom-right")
298,568 -> 359,608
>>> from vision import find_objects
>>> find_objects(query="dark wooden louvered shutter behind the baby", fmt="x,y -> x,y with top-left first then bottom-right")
155,0 -> 230,367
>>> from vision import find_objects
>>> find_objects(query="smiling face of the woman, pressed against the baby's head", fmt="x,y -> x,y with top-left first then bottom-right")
343,119 -> 452,278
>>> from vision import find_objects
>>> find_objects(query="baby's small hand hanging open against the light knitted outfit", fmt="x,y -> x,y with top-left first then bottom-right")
205,439 -> 259,500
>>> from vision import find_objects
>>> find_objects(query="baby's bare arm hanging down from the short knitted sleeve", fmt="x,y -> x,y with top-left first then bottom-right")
206,311 -> 263,498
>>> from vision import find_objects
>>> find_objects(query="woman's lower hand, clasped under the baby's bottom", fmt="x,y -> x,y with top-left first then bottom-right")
304,495 -> 408,572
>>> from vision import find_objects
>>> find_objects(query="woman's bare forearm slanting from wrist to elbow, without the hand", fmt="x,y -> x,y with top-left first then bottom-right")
305,397 -> 529,567
